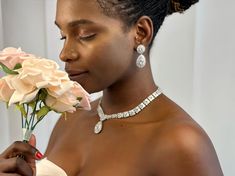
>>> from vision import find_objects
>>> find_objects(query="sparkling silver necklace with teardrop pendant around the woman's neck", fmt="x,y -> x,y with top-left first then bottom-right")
94,88 -> 162,134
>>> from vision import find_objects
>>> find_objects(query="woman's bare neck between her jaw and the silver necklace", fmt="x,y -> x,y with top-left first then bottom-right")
101,68 -> 157,114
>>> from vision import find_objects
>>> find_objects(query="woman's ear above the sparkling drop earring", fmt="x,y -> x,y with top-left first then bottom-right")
135,16 -> 153,47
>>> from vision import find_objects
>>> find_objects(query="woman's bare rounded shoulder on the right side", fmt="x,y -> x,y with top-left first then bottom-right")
149,104 -> 223,176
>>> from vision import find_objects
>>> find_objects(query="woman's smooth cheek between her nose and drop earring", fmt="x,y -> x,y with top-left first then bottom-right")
81,33 -> 135,92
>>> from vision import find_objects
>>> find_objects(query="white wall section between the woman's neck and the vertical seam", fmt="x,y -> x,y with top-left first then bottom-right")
151,7 -> 195,114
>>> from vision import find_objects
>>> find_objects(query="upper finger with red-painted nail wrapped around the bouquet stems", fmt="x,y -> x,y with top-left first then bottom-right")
1,141 -> 43,160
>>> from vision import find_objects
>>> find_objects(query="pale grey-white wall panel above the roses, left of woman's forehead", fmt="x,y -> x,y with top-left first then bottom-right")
2,0 -> 46,55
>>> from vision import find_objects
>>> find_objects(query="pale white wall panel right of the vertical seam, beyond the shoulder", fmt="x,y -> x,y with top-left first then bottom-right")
194,0 -> 235,176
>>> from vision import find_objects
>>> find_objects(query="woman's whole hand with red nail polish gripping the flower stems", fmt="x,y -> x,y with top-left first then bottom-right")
0,135 -> 43,176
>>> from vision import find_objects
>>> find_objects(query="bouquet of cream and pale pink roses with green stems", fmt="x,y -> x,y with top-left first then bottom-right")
0,48 -> 90,141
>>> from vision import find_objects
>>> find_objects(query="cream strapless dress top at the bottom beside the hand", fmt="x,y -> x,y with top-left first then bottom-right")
36,158 -> 68,176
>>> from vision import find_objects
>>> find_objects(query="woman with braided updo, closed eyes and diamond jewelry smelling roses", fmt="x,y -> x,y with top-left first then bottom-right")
0,0 -> 223,176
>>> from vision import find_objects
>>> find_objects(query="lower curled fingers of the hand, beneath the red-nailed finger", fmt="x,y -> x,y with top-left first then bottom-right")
0,157 -> 33,176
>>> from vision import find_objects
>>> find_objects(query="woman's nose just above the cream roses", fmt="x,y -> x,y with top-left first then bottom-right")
60,43 -> 79,62
